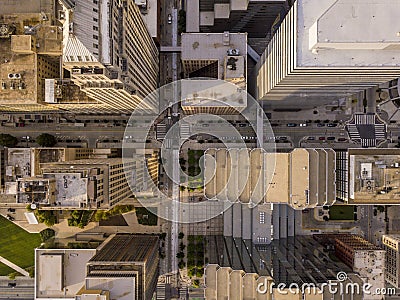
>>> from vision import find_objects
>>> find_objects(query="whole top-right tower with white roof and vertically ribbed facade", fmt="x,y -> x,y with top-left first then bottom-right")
257,0 -> 400,100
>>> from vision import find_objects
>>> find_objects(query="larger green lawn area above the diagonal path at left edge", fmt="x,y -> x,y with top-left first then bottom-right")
0,216 -> 41,274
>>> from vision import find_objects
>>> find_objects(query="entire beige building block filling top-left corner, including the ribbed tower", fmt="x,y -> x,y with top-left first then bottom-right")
0,0 -> 158,113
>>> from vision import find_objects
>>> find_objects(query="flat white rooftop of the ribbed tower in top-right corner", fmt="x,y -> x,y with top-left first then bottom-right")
295,0 -> 400,67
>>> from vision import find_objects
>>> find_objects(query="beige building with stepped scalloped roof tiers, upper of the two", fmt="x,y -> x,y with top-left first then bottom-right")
204,148 -> 336,209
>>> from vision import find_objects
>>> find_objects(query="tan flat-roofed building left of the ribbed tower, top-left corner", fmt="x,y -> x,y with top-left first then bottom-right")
0,0 -> 63,112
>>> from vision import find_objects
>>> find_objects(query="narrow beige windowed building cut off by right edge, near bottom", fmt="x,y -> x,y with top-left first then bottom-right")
382,234 -> 400,288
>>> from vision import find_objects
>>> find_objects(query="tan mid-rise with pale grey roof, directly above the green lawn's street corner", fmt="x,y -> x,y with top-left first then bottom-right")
23,158 -> 133,209
